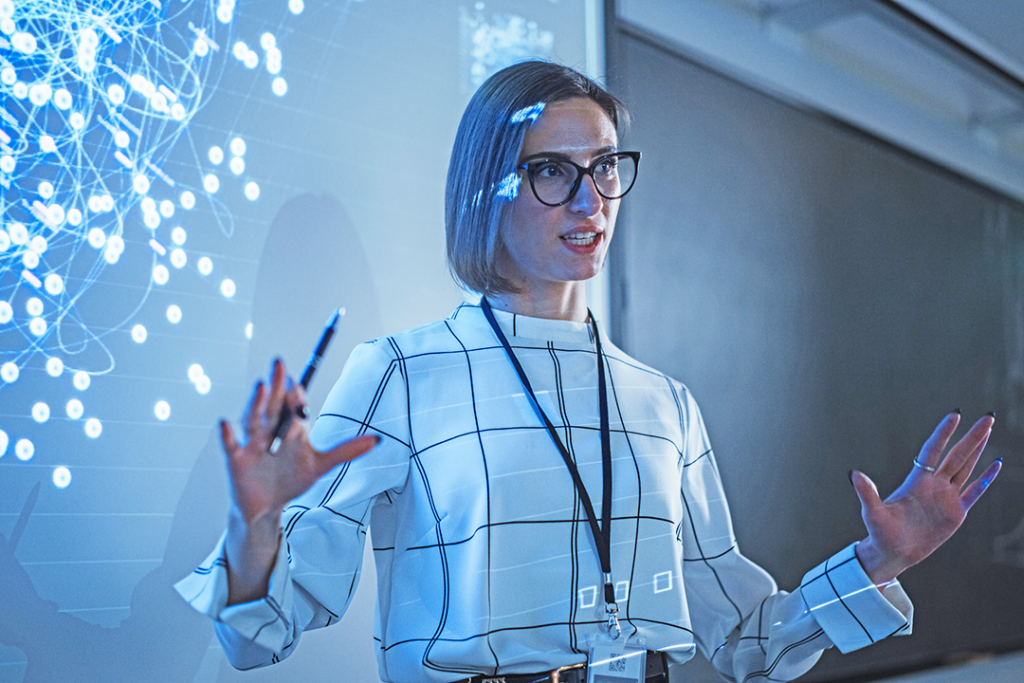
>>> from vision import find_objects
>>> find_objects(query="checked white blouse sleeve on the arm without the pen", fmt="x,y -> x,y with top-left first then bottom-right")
680,388 -> 913,681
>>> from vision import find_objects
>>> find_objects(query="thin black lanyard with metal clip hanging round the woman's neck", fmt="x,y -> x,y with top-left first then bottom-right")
480,297 -> 621,637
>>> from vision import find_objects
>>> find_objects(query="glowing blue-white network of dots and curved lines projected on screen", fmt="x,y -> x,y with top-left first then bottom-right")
0,0 -> 304,487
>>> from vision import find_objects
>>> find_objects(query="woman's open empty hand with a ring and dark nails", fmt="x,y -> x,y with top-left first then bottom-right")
850,413 -> 1002,585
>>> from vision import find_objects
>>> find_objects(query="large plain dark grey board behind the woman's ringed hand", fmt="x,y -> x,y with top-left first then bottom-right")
608,26 -> 1024,680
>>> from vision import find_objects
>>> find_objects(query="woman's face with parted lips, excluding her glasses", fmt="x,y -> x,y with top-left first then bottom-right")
500,98 -> 618,294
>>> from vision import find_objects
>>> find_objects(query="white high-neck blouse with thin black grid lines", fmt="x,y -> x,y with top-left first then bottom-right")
177,304 -> 912,683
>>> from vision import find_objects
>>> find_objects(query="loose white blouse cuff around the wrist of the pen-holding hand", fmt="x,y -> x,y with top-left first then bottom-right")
174,537 -> 294,650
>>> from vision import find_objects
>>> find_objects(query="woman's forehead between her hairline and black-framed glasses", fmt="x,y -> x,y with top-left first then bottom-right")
522,97 -> 618,157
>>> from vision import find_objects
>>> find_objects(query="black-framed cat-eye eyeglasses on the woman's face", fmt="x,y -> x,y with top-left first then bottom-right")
519,152 -> 640,207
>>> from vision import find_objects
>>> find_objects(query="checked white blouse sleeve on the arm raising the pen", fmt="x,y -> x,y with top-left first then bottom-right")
175,342 -> 410,669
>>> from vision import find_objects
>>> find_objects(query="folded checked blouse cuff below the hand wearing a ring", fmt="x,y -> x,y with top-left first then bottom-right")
800,543 -> 913,653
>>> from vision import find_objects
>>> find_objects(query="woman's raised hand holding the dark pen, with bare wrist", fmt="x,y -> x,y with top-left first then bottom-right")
220,359 -> 380,605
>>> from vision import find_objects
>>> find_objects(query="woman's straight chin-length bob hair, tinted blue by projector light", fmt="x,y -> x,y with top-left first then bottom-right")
444,61 -> 629,296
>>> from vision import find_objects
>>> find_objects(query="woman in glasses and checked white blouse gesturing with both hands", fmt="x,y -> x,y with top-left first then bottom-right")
179,62 -> 999,682
